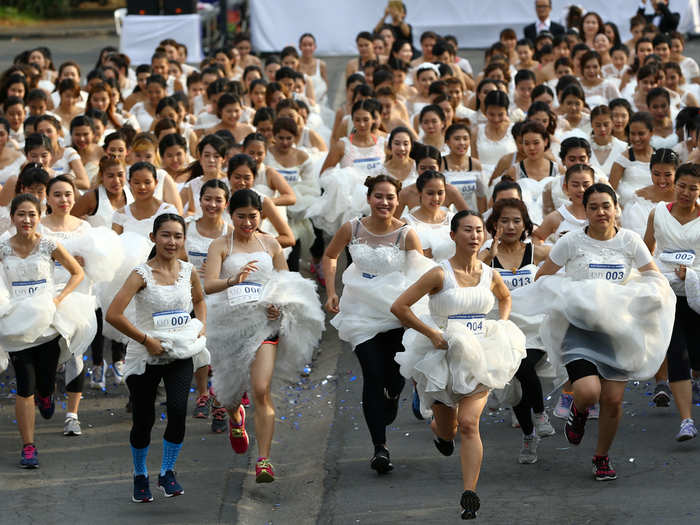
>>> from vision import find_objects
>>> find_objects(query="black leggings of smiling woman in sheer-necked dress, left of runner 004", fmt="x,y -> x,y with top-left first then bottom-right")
355,328 -> 406,445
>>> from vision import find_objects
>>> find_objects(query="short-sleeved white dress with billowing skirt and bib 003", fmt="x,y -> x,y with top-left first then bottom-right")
513,229 -> 676,381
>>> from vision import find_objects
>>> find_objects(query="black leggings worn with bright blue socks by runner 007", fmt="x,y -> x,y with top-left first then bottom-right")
126,357 -> 193,448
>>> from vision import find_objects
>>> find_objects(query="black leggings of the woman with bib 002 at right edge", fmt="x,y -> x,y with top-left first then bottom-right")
667,296 -> 700,382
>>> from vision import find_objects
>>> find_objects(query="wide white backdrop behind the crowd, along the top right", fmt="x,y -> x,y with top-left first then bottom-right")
250,0 -> 697,55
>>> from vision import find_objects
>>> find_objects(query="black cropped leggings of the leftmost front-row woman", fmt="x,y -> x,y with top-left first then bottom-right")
9,336 -> 61,397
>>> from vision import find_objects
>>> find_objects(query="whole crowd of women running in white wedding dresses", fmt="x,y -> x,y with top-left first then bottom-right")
0,2 -> 700,519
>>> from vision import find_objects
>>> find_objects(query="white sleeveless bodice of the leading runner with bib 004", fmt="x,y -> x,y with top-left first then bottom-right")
428,261 -> 494,328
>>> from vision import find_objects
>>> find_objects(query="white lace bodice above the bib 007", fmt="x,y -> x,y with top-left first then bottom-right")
134,261 -> 193,329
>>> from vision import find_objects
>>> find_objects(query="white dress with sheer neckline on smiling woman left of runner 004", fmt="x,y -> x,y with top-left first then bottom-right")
331,218 -> 434,349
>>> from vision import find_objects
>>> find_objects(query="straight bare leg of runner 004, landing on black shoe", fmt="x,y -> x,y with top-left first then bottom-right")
457,391 -> 489,491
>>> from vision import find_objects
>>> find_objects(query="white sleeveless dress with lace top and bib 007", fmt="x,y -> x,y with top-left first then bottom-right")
124,261 -> 207,379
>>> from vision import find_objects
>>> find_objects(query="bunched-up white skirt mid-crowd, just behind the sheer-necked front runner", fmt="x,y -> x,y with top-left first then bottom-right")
306,167 -> 370,236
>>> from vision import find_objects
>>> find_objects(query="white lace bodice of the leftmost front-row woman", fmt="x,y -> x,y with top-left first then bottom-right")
0,236 -> 56,286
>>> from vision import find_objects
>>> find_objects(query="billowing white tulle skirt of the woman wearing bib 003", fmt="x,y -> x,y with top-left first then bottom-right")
513,271 -> 676,381
